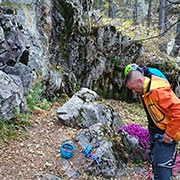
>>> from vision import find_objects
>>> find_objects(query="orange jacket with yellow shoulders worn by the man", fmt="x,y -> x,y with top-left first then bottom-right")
142,75 -> 180,141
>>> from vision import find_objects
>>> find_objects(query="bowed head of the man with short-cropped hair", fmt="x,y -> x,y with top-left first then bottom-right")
124,70 -> 145,95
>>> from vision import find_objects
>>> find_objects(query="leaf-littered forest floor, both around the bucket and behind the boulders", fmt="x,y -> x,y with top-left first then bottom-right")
0,100 -> 177,180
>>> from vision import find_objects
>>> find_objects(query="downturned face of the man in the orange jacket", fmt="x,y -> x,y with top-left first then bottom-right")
126,79 -> 143,95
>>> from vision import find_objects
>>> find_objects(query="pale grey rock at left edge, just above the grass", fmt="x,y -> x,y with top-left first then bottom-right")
0,71 -> 27,120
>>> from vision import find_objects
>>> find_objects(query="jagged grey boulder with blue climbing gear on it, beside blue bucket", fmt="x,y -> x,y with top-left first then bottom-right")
76,123 -> 127,179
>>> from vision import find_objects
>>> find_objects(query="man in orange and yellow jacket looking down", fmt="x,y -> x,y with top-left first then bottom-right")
124,70 -> 180,180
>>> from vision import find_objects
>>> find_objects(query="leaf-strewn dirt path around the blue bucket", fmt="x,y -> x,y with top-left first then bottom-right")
0,100 -> 179,180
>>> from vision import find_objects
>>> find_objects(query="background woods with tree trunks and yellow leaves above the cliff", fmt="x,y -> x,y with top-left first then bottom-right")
93,0 -> 180,56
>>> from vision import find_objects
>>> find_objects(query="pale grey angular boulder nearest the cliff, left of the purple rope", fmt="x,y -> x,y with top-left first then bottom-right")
57,88 -> 124,131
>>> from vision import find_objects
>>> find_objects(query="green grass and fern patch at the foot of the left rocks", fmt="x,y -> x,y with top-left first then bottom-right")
0,82 -> 51,142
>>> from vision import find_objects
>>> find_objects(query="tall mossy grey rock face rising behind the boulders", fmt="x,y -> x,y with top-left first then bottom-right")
0,0 -> 179,119
